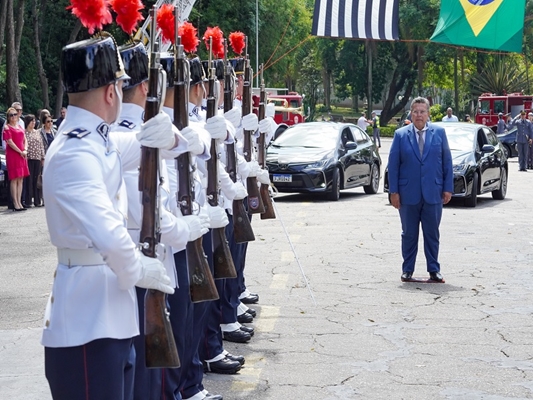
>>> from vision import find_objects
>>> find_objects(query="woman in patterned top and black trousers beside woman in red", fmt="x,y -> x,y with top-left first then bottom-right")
24,114 -> 44,208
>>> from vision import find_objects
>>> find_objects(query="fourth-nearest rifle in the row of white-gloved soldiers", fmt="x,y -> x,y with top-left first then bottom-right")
224,47 -> 255,243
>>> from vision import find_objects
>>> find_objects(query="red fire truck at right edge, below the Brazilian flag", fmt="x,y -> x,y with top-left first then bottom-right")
476,93 -> 533,126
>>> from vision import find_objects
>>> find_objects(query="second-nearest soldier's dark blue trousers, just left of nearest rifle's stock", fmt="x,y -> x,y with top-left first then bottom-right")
133,287 -> 163,400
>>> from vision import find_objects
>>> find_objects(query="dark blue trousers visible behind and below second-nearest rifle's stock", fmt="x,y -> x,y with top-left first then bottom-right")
181,231 -> 213,399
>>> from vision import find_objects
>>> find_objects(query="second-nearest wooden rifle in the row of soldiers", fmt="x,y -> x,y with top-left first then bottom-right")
174,35 -> 219,303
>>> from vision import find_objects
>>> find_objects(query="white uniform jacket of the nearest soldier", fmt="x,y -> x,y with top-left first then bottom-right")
41,106 -> 145,347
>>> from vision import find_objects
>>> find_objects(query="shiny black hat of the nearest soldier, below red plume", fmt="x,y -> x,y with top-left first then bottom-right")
61,32 -> 129,93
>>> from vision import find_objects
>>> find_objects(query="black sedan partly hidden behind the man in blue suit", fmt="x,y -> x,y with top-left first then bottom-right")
384,122 -> 508,207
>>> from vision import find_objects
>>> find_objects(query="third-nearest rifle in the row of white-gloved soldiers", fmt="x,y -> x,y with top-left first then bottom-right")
206,54 -> 237,279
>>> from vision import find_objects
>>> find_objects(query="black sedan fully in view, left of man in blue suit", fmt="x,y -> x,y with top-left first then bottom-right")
266,121 -> 381,200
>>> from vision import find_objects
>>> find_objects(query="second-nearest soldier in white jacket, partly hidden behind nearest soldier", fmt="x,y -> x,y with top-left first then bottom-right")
116,42 -> 209,400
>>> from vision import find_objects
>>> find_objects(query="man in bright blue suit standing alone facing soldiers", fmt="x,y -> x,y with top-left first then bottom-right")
388,97 -> 453,282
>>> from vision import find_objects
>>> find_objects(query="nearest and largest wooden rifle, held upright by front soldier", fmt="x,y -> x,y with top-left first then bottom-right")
139,7 -> 180,368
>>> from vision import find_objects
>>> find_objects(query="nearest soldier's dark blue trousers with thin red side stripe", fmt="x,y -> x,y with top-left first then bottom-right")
44,339 -> 135,400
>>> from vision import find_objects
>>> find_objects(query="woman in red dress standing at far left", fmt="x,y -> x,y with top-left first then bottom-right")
4,107 -> 30,211
